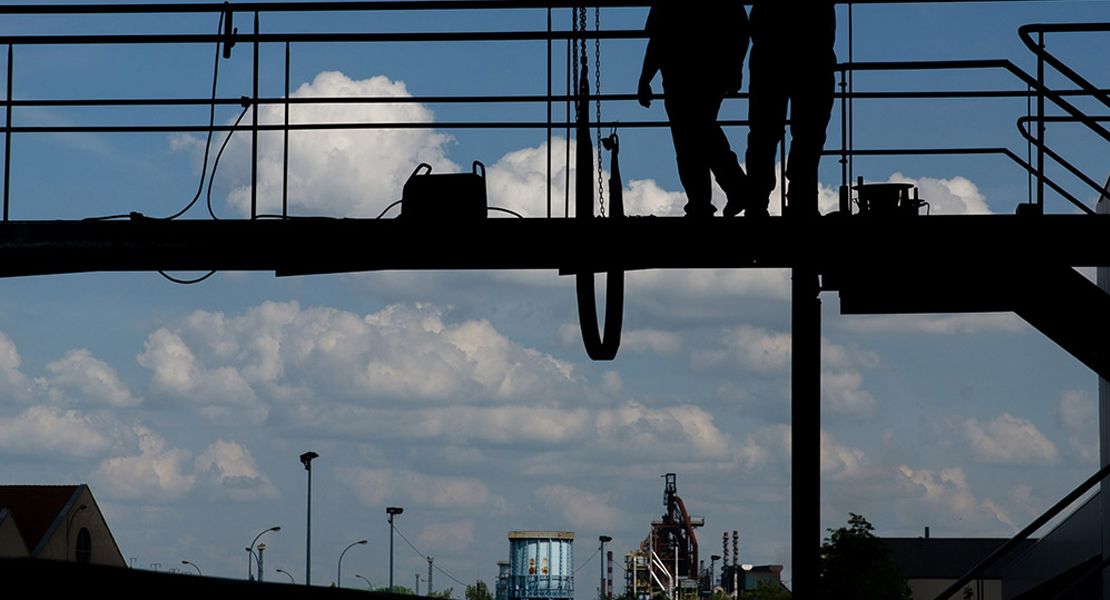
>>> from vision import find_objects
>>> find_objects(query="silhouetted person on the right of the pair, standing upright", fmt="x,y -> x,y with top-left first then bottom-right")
741,0 -> 836,216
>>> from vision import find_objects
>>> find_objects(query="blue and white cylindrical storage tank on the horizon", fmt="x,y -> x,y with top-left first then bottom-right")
508,531 -> 574,600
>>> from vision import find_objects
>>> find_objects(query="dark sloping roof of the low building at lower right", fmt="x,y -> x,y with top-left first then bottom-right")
881,538 -> 1037,579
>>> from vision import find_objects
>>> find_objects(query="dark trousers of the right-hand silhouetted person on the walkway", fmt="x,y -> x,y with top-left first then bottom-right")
746,44 -> 836,215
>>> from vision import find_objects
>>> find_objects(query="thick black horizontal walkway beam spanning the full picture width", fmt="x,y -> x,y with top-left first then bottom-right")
0,215 -> 1110,277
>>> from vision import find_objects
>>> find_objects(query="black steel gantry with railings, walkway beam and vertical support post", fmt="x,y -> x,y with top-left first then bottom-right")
0,0 -> 1110,598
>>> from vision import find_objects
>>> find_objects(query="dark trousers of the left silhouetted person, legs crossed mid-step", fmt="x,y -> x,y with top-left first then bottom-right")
664,81 -> 745,215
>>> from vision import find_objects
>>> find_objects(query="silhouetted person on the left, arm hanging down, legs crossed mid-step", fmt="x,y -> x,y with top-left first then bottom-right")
637,0 -> 749,216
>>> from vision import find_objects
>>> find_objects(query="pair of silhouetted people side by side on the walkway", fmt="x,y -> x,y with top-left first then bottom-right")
637,0 -> 836,217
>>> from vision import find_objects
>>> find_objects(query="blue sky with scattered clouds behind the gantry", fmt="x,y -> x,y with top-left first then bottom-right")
0,1 -> 1110,599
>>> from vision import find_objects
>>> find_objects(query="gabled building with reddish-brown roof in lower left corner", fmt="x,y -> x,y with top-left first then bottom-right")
0,484 -> 127,567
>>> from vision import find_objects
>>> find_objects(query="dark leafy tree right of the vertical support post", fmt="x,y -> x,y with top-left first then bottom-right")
820,512 -> 911,600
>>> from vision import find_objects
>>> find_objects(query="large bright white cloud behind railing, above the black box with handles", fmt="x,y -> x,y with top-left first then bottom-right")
218,71 -> 457,217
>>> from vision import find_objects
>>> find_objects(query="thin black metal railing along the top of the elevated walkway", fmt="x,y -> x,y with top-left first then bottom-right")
0,0 -> 1110,221
